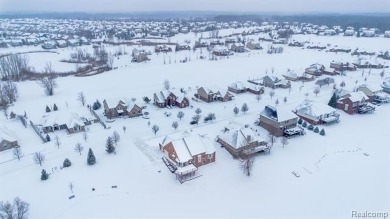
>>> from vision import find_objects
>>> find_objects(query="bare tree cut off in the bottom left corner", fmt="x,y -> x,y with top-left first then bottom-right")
0,197 -> 30,219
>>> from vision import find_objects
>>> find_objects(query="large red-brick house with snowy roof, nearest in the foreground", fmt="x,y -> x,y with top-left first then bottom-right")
159,132 -> 216,179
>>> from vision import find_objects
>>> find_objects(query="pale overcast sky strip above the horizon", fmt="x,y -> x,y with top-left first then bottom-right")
0,0 -> 390,12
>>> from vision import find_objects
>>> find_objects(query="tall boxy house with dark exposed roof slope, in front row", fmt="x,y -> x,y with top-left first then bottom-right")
259,105 -> 298,137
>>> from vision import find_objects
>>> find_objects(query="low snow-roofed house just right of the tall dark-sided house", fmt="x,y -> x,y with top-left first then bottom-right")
294,100 -> 340,125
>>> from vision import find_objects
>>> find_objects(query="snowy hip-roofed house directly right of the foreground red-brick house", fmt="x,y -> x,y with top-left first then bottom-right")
217,128 -> 269,158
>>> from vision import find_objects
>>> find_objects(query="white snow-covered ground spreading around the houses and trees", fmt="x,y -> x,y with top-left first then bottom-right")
0,33 -> 390,218
